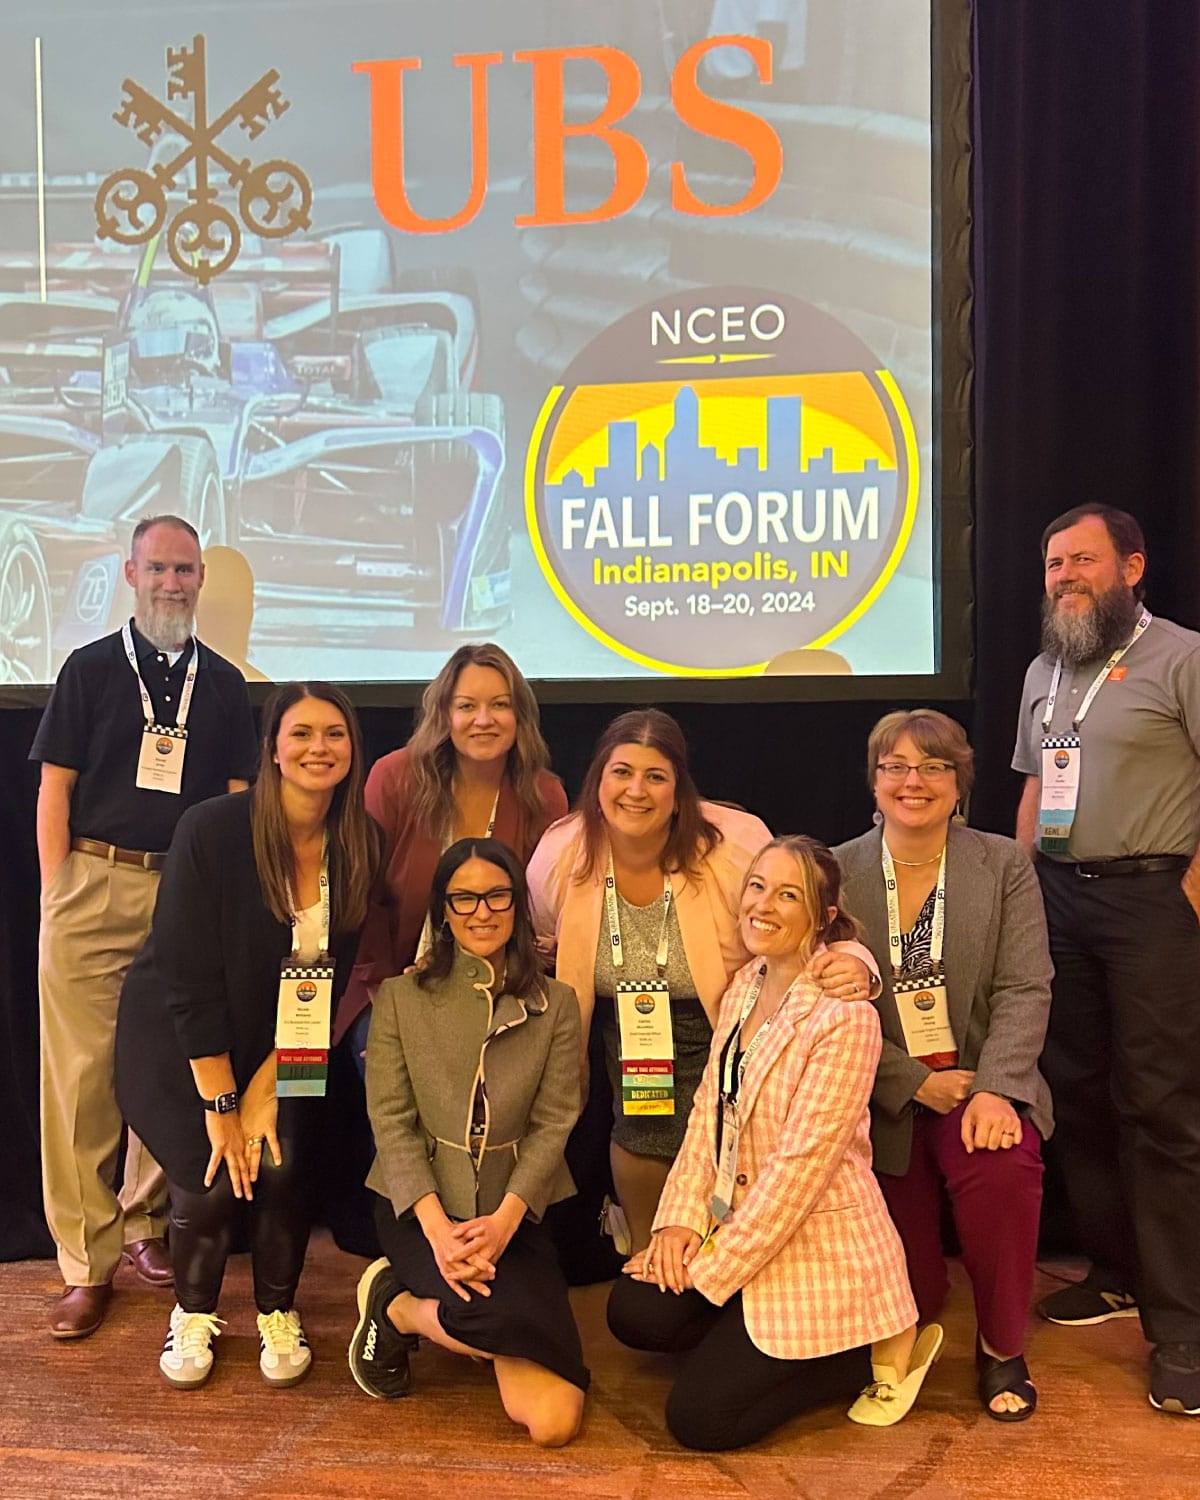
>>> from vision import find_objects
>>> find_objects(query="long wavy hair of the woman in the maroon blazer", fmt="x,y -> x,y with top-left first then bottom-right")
408,641 -> 551,840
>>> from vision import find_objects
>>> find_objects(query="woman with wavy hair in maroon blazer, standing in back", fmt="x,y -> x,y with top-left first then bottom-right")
333,644 -> 567,1070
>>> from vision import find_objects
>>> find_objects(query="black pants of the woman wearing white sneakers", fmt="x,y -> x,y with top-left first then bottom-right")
168,1100 -> 321,1313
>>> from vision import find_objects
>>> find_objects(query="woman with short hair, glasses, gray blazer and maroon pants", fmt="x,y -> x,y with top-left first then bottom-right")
834,708 -> 1053,1422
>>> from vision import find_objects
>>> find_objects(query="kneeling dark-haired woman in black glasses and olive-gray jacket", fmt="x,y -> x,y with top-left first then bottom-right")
350,839 -> 588,1446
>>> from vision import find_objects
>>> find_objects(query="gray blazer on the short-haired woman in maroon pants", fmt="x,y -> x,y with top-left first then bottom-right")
834,824 -> 1055,1178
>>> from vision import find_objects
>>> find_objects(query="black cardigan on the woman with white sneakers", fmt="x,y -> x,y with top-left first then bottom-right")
116,792 -> 359,1193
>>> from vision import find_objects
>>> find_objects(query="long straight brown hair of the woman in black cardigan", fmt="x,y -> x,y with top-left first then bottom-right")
251,683 -> 380,933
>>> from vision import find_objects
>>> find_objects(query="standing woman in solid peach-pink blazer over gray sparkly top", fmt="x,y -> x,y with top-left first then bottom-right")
530,708 -> 876,1251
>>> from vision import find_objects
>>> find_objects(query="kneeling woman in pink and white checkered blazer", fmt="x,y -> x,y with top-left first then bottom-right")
609,837 -> 942,1451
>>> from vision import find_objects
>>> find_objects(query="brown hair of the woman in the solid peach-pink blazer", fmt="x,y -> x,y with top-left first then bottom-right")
575,708 -> 722,884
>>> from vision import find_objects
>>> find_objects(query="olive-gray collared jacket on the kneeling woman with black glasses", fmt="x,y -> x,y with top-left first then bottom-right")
366,950 -> 581,1220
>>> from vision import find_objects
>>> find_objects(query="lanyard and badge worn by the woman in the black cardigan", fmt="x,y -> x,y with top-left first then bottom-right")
275,834 -> 333,1098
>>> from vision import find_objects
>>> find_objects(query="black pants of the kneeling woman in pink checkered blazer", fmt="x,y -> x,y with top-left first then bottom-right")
609,1277 -> 872,1452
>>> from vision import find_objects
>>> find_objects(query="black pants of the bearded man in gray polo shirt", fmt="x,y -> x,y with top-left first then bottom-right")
1038,860 -> 1200,1344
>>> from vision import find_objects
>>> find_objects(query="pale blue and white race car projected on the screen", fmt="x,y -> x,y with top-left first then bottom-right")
0,230 -> 512,683
